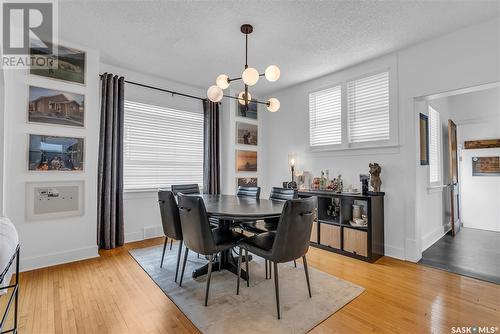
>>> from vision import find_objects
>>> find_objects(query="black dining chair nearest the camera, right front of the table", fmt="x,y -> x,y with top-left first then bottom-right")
236,197 -> 315,319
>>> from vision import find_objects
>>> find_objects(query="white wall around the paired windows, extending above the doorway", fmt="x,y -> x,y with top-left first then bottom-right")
261,19 -> 500,261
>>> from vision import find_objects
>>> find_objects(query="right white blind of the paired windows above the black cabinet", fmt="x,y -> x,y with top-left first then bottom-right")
347,72 -> 390,143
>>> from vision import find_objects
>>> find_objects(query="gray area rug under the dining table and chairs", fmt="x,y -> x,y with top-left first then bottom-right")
130,244 -> 364,333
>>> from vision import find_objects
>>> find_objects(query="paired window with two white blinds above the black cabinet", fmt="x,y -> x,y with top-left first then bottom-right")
309,69 -> 397,149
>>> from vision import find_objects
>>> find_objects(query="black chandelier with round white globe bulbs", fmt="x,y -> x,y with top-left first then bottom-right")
207,24 -> 280,112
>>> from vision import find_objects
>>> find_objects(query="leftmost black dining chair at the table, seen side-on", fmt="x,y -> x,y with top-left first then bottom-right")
158,189 -> 182,282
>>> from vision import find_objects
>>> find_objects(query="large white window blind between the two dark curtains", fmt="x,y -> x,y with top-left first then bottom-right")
124,101 -> 203,190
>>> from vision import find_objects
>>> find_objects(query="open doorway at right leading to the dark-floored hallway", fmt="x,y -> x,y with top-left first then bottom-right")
417,84 -> 500,284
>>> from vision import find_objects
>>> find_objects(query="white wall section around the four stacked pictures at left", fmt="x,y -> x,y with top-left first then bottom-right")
2,41 -> 99,270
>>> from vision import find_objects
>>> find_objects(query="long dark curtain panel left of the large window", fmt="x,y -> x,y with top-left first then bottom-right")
97,73 -> 125,249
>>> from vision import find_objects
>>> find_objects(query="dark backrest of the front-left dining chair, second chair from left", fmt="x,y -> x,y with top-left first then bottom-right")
179,195 -> 217,255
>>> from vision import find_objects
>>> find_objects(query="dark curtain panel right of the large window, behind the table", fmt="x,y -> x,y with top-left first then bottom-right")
203,100 -> 220,194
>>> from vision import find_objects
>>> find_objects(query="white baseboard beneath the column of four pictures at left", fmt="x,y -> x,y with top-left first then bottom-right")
20,245 -> 99,271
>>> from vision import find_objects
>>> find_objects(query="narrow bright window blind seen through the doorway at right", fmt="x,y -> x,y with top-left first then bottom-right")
429,106 -> 441,184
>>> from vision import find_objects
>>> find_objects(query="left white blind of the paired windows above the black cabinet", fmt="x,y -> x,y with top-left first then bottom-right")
309,85 -> 342,146
